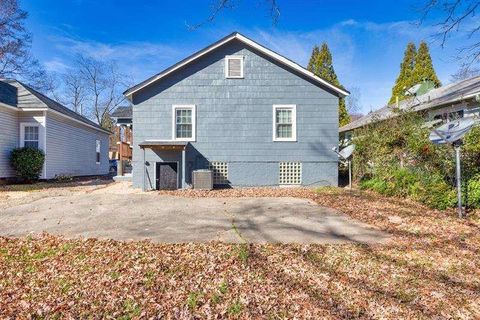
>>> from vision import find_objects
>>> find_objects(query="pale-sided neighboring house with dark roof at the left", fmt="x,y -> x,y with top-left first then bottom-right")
0,80 -> 110,179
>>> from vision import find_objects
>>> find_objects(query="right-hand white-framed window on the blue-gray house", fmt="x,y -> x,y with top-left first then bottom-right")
273,105 -> 297,141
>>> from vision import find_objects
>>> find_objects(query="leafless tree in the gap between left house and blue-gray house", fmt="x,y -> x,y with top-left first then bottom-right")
75,56 -> 129,127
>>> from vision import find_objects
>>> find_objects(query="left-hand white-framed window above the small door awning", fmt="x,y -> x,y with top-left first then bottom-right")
173,105 -> 196,141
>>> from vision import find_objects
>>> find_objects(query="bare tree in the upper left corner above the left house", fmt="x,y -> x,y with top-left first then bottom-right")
0,0 -> 48,91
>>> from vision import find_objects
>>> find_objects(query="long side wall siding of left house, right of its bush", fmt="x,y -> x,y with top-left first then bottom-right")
46,112 -> 109,179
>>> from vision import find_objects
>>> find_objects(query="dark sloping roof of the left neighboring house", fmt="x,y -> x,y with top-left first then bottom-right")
0,80 -> 111,134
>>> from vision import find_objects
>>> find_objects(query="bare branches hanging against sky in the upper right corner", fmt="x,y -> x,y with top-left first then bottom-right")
421,0 -> 480,69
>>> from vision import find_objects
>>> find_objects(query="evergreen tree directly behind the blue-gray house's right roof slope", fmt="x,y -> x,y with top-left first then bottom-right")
307,42 -> 351,126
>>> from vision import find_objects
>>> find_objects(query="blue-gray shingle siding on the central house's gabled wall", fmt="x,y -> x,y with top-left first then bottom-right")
133,42 -> 338,189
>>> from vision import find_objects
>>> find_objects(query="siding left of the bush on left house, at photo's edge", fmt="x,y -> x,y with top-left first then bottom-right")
0,106 -> 19,178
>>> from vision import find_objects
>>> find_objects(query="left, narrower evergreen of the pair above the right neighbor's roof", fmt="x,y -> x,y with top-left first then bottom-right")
388,42 -> 417,104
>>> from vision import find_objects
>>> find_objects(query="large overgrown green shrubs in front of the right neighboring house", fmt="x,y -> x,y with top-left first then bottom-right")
353,111 -> 472,209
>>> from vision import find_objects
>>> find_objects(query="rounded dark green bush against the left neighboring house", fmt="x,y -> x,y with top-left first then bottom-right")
10,148 -> 45,182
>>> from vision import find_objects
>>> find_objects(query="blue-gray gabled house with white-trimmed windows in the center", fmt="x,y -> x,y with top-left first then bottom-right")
125,32 -> 348,190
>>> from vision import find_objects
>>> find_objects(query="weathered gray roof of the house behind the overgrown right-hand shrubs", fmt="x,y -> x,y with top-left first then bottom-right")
339,76 -> 480,132
